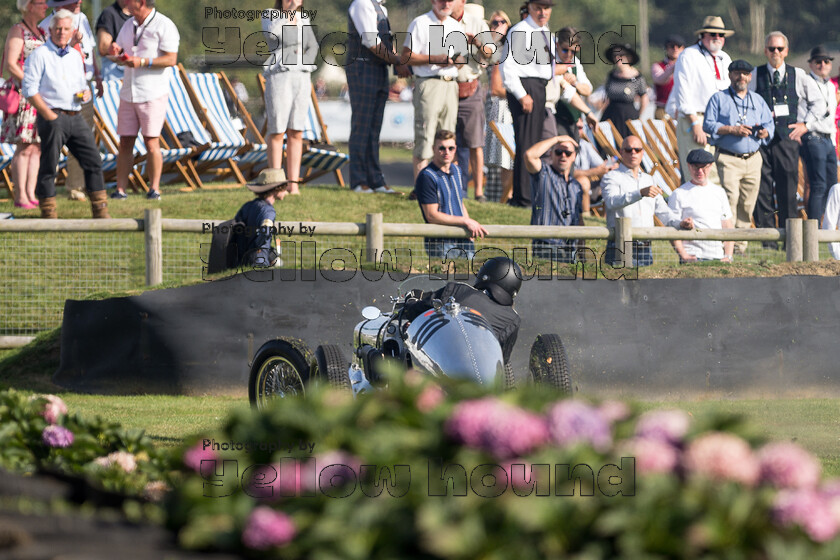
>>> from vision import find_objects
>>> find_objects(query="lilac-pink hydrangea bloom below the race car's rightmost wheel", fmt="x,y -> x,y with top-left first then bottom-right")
548,399 -> 612,451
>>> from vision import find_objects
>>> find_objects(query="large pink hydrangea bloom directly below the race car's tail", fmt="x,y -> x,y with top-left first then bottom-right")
446,397 -> 548,459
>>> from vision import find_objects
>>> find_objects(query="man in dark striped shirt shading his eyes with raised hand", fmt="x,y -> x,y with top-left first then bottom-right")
525,135 -> 583,263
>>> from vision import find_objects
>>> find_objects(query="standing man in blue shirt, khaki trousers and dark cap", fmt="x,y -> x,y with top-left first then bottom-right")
703,60 -> 776,254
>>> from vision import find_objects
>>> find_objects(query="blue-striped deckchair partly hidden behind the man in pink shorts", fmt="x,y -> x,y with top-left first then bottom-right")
94,80 -> 196,191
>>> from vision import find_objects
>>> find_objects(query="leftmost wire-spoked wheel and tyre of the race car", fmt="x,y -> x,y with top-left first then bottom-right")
248,339 -> 311,409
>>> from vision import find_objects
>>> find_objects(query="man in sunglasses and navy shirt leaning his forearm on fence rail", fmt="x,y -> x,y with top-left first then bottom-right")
414,130 -> 487,259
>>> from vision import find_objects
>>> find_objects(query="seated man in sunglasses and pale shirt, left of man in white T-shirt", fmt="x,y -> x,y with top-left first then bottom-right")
601,136 -> 694,266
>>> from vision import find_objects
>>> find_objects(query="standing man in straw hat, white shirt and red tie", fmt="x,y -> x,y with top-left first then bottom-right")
671,16 -> 735,179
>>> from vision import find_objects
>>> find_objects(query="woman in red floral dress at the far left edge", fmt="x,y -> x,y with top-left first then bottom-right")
0,0 -> 47,208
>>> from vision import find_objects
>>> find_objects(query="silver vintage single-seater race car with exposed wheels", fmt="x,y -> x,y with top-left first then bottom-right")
248,276 -> 571,408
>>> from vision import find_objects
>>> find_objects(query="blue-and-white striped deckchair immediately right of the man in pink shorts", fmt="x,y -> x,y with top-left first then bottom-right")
166,65 -> 250,185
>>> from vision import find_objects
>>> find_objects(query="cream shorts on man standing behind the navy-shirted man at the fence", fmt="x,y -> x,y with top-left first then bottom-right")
414,78 -> 458,159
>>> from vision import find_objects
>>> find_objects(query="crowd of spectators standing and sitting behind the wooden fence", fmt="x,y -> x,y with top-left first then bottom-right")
0,0 -> 840,264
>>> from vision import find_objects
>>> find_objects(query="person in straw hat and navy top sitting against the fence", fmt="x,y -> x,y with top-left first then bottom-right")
234,169 -> 288,266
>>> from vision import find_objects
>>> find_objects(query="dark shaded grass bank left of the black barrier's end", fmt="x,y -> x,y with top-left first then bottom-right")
0,328 -> 62,393
